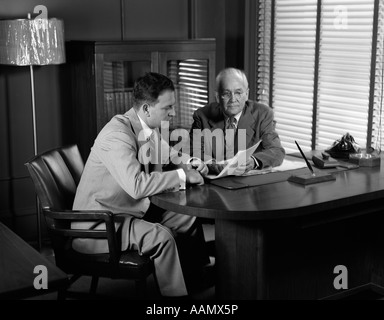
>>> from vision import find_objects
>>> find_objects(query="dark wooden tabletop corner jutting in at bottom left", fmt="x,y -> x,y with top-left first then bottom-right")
0,223 -> 69,300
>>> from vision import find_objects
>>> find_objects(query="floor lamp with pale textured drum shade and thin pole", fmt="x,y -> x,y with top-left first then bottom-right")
0,18 -> 65,251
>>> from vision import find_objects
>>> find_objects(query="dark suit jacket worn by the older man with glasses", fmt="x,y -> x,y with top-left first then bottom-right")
190,100 -> 285,167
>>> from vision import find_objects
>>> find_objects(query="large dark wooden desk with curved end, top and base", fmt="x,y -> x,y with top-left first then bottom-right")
151,156 -> 384,299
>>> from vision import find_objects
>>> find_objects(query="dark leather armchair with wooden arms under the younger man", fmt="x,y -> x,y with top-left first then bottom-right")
25,145 -> 154,297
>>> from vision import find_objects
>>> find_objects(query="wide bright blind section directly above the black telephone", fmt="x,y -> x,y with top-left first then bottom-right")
315,0 -> 374,149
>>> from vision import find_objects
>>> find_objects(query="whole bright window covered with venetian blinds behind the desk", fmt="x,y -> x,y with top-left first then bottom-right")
250,0 -> 384,153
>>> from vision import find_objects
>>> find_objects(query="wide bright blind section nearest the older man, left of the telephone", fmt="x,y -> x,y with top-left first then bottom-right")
272,0 -> 317,153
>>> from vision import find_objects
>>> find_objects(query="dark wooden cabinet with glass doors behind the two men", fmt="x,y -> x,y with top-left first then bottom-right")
66,39 -> 216,160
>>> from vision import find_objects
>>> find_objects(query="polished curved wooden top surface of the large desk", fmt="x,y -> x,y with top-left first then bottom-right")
151,157 -> 384,220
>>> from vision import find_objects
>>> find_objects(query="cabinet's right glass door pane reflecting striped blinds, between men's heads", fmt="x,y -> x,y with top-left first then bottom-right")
168,59 -> 208,129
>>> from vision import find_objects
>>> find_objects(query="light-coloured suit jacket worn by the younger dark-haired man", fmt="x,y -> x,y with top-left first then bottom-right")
72,109 -> 189,253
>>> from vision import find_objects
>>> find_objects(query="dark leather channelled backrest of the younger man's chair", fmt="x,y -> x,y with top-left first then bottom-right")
26,145 -> 84,210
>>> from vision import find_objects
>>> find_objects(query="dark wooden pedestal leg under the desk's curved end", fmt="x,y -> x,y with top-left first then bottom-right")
215,219 -> 266,300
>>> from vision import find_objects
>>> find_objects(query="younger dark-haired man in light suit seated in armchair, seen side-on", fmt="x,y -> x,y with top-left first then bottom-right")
72,73 -> 209,296
